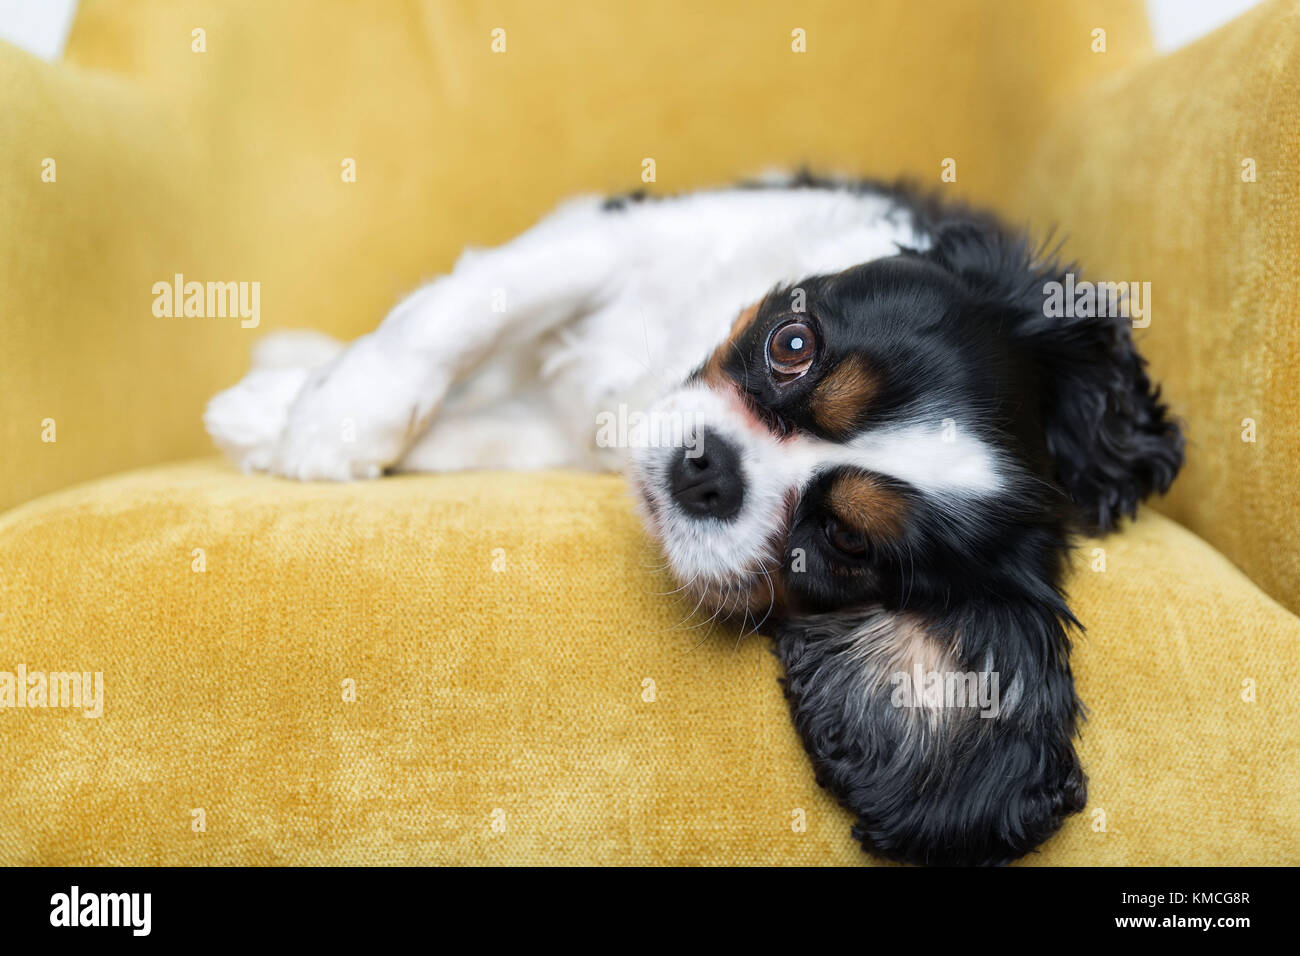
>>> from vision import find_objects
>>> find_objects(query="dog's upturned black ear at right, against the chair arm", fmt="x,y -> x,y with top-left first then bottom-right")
926,220 -> 1183,532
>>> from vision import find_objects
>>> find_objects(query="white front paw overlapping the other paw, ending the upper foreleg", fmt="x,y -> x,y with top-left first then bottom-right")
270,339 -> 442,481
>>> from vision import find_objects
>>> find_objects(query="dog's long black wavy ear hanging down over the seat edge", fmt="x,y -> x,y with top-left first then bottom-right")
776,602 -> 1087,865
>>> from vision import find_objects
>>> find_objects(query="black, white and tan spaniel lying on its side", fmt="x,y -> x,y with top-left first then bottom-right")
205,174 -> 1183,865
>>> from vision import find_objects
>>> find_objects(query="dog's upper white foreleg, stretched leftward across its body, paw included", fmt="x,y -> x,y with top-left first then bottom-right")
263,200 -> 619,480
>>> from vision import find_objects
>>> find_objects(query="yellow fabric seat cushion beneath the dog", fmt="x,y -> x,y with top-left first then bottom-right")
0,462 -> 1300,864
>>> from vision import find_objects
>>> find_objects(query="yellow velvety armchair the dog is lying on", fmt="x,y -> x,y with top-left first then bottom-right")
0,0 -> 1300,864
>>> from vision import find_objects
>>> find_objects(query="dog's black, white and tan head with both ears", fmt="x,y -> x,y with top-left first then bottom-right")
631,221 -> 1182,861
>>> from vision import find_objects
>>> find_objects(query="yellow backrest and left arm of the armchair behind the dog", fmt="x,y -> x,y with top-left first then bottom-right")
0,0 -> 1148,509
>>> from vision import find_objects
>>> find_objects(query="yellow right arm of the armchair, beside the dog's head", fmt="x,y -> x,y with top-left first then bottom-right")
1015,0 -> 1300,610
